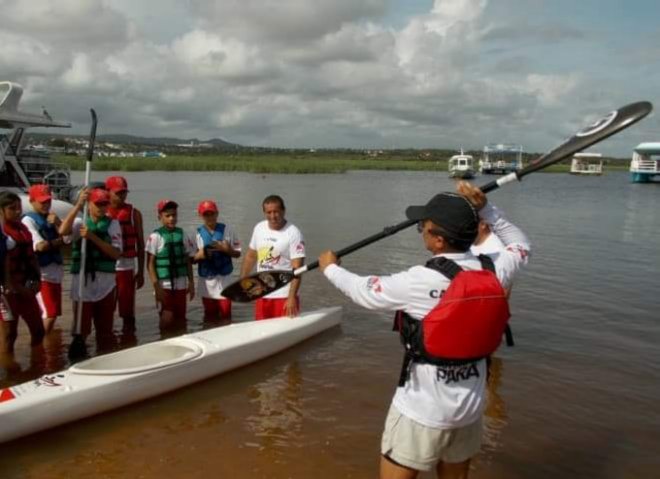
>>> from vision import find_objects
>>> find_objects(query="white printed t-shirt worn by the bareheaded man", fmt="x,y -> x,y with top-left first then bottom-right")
250,220 -> 305,299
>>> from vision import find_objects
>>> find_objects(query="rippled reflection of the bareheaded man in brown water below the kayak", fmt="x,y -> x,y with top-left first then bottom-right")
246,361 -> 302,457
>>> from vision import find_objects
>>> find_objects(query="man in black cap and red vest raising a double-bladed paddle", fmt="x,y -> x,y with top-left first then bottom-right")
319,182 -> 530,479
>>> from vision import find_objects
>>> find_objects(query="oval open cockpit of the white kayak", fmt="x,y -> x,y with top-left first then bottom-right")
69,339 -> 203,375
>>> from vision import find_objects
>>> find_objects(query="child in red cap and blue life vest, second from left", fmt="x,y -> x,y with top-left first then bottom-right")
23,185 -> 64,333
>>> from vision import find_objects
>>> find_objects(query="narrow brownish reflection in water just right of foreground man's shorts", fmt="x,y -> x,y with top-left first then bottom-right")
481,356 -> 508,462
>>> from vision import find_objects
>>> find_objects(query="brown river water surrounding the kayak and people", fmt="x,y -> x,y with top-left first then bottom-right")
0,172 -> 660,479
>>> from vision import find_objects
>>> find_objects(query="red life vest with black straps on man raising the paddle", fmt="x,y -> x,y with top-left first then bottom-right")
395,255 -> 510,386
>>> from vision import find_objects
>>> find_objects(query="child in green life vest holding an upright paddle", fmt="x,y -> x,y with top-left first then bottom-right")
60,188 -> 122,350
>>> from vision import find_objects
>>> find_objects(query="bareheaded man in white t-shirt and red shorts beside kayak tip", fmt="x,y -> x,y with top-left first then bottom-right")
241,195 -> 305,320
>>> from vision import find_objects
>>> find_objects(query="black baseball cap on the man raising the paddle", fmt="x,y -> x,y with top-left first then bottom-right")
406,192 -> 479,247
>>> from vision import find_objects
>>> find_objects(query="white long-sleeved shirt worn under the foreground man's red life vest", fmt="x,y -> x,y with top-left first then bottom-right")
324,205 -> 530,428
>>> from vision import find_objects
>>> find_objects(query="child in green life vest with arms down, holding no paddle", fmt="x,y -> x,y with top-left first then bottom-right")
145,200 -> 197,333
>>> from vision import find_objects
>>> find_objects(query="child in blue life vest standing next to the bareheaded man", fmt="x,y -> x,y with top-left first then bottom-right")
194,200 -> 241,323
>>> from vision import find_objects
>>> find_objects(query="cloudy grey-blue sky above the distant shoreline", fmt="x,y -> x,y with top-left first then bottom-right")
0,0 -> 660,156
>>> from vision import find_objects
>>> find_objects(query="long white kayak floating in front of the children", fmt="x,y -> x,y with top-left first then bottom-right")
0,307 -> 342,442
